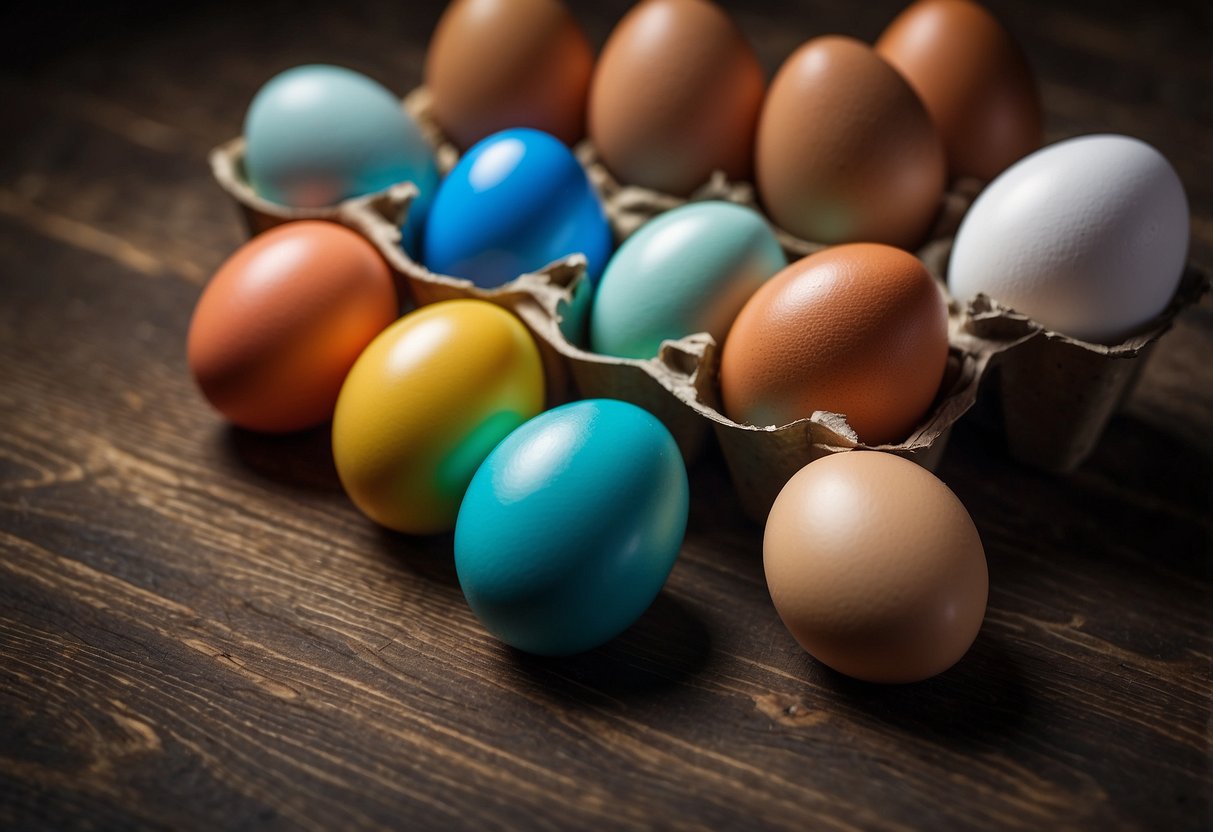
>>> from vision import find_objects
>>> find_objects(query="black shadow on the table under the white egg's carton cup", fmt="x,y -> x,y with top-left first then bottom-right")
940,411 -> 1213,592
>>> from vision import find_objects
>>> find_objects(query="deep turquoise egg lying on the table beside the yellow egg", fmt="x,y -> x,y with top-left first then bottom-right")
455,399 -> 689,656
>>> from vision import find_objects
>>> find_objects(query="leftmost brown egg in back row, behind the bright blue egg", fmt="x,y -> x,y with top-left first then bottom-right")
426,0 -> 594,149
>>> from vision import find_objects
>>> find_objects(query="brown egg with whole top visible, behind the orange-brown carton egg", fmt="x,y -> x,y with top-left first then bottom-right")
754,35 -> 945,249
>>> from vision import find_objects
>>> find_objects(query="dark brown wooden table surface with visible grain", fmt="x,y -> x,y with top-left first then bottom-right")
0,0 -> 1213,830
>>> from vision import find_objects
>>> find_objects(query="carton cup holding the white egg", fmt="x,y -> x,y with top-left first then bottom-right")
950,263 -> 1209,474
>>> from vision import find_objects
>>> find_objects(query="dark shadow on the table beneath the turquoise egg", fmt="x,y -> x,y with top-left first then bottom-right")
507,592 -> 712,707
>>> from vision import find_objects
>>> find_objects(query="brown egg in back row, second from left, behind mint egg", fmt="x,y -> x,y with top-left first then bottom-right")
590,0 -> 764,195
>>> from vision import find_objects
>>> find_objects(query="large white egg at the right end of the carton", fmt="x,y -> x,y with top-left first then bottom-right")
947,135 -> 1189,343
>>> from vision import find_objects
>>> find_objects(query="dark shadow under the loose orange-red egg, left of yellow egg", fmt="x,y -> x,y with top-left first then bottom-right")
221,423 -> 341,492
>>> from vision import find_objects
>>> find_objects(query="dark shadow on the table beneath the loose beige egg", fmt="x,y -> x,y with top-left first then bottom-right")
805,625 -> 1032,750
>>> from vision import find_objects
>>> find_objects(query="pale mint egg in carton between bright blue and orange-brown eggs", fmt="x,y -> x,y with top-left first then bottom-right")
590,201 -> 787,358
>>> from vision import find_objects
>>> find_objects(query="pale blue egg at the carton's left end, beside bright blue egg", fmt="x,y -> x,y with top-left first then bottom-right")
244,64 -> 438,247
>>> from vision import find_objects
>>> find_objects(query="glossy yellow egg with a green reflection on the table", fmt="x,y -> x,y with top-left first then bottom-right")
332,300 -> 543,534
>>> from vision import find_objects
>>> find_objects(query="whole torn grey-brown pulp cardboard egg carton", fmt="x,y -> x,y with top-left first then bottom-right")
211,87 -> 1208,522
